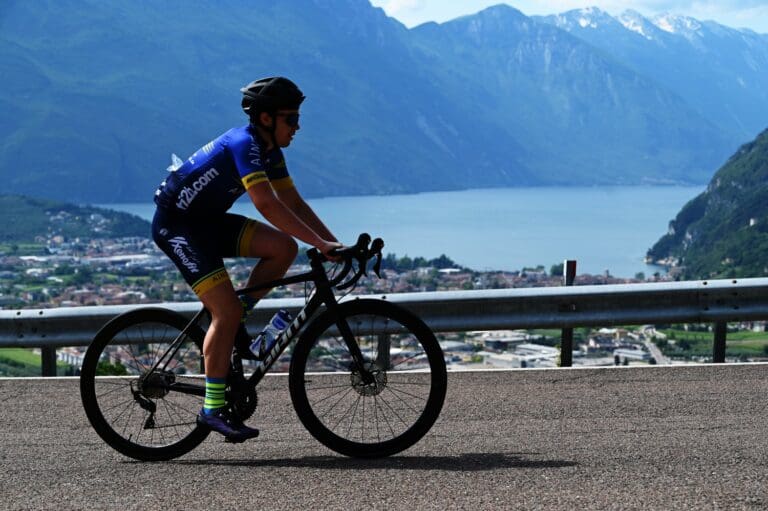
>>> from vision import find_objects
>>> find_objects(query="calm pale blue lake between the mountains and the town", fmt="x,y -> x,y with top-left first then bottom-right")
100,185 -> 705,277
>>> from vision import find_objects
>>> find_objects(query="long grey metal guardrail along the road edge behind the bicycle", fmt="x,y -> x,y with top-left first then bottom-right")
0,278 -> 768,374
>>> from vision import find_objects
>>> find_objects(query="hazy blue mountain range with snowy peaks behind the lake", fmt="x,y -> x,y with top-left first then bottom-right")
0,0 -> 768,203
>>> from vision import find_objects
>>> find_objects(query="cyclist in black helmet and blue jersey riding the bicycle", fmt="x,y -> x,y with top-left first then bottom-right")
152,77 -> 341,442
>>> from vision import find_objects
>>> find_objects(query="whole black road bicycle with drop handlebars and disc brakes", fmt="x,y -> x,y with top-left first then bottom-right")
80,234 -> 447,461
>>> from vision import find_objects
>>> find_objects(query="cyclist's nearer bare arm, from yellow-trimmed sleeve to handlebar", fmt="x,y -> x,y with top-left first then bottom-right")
248,181 -> 338,253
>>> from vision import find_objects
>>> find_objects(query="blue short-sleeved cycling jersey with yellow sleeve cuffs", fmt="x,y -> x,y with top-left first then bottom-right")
155,126 -> 293,216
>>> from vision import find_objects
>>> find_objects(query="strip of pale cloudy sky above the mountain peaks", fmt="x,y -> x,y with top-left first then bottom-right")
371,0 -> 768,34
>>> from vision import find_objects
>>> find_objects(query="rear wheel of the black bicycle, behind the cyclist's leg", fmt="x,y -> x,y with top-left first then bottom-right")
80,307 -> 210,461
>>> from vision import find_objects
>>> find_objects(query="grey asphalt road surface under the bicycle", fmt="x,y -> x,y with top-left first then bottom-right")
0,365 -> 768,511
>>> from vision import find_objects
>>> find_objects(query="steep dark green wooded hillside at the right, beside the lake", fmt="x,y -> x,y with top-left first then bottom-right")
648,130 -> 768,279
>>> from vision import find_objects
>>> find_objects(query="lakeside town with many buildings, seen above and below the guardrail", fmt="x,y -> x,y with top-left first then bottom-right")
0,228 -> 768,375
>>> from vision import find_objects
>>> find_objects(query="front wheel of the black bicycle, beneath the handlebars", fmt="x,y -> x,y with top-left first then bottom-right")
289,299 -> 447,458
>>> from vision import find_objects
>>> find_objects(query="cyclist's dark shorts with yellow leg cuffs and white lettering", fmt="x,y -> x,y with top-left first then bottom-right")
152,208 -> 256,296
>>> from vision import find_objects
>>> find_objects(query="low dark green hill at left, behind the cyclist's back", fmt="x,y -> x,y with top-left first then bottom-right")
0,195 -> 150,243
